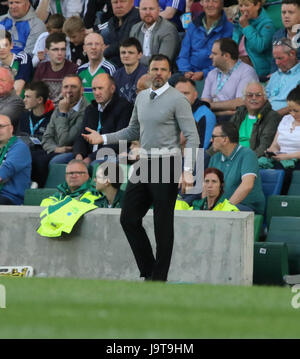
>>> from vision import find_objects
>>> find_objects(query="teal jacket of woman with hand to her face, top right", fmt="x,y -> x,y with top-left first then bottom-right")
232,9 -> 275,76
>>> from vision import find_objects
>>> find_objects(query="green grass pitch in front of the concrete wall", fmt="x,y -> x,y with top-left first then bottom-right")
0,278 -> 300,339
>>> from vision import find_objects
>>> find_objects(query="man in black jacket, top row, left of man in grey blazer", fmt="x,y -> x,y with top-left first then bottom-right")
102,0 -> 141,67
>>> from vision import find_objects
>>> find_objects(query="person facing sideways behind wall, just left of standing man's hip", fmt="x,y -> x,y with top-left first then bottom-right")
95,162 -> 124,208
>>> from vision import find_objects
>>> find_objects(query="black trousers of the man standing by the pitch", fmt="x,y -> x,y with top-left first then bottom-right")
121,157 -> 178,281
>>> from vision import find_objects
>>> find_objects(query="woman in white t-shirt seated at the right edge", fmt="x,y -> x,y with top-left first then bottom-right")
260,85 -> 300,194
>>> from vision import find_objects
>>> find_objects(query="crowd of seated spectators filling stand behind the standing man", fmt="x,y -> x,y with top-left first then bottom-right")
0,0 -> 300,214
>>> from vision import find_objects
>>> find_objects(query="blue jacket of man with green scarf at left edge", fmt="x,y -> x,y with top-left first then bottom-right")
0,139 -> 31,204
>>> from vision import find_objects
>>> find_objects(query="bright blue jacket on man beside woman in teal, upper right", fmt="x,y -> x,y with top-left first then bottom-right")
176,12 -> 233,77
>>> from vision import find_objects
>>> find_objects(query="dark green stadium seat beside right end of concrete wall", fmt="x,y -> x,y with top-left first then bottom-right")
253,242 -> 289,285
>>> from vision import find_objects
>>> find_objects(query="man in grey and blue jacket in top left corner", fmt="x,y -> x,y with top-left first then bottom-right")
0,0 -> 46,55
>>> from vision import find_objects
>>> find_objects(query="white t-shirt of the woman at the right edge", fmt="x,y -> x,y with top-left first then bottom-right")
277,115 -> 300,153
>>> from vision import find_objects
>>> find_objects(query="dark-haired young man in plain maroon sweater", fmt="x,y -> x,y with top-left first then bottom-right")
34,33 -> 77,106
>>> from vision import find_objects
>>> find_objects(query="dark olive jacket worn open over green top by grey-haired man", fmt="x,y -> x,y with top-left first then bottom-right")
230,101 -> 281,157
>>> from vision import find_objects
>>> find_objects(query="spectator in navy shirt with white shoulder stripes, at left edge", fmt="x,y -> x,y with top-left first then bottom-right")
0,30 -> 33,96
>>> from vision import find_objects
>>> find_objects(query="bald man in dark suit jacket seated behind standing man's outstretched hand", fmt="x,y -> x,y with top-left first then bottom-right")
73,74 -> 133,164
